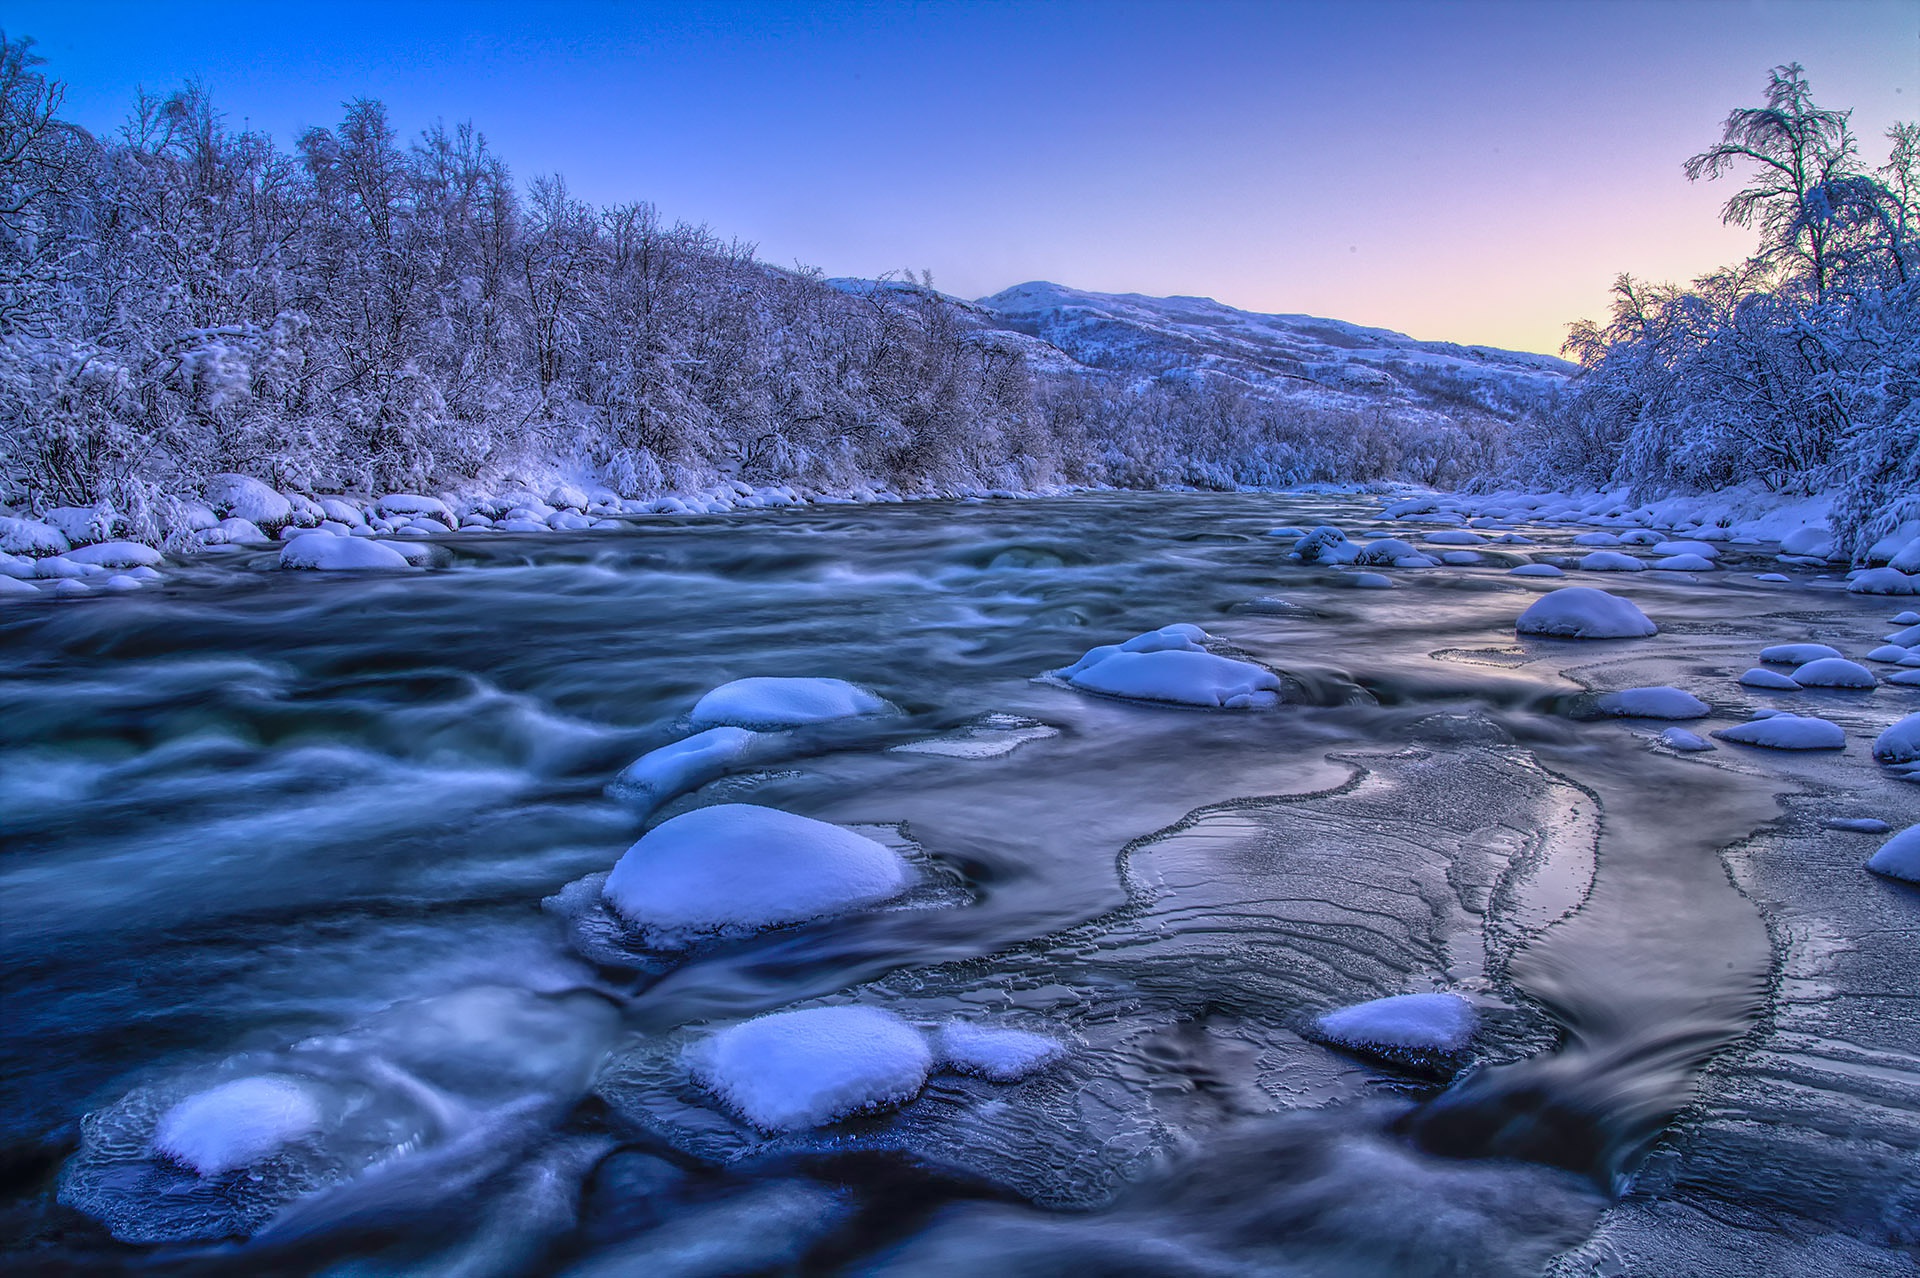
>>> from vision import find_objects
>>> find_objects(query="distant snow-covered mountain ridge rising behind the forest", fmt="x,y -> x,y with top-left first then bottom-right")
975,282 -> 1572,413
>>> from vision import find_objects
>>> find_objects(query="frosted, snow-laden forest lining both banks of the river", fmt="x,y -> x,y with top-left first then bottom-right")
0,36 -> 1920,545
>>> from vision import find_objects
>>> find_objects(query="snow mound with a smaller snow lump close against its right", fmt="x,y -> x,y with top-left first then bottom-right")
685,1007 -> 933,1132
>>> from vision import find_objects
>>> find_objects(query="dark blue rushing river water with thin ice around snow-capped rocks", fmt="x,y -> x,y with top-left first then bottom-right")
0,495 -> 1920,1274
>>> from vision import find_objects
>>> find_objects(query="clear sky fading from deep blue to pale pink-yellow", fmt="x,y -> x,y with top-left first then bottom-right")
11,0 -> 1920,349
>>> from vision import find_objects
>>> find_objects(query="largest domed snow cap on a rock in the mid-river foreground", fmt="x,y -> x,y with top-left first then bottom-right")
603,804 -> 912,950
